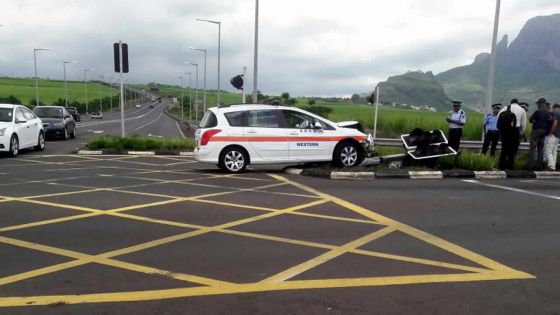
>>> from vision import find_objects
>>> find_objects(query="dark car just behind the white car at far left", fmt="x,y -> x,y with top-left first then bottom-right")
33,106 -> 76,140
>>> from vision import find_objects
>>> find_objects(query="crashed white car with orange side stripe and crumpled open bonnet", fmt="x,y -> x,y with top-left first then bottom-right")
194,105 -> 371,173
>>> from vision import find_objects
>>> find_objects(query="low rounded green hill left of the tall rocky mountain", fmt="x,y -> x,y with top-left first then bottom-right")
379,71 -> 451,111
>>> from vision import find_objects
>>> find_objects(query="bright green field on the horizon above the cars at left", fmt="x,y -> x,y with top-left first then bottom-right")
0,78 -> 119,104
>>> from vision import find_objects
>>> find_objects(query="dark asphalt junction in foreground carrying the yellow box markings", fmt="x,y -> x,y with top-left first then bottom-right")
0,155 -> 560,314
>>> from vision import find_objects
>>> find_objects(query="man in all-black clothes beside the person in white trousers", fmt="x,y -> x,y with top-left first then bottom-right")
525,98 -> 552,170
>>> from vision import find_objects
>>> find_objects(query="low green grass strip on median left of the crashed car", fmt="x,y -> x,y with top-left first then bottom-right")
86,136 -> 195,151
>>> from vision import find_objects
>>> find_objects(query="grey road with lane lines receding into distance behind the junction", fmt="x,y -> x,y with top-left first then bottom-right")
15,101 -> 182,156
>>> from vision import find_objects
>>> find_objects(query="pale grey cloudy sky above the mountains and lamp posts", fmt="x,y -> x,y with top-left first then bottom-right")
0,0 -> 560,96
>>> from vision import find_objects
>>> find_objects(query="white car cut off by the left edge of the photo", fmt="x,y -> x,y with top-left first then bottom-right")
0,104 -> 45,156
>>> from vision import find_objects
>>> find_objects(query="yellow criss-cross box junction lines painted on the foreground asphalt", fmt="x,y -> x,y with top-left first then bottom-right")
0,162 -> 534,307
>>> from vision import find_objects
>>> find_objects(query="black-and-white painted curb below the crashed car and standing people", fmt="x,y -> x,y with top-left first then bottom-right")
284,167 -> 560,181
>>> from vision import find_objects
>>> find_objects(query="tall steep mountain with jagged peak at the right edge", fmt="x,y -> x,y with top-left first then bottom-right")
436,14 -> 560,110
